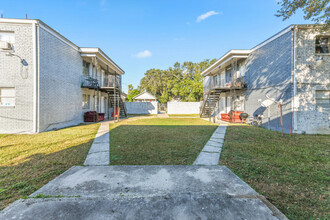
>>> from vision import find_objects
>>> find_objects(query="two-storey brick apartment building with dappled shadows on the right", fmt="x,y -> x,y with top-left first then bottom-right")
201,25 -> 330,134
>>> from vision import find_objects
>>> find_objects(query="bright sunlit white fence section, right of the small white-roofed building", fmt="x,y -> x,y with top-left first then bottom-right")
167,102 -> 201,115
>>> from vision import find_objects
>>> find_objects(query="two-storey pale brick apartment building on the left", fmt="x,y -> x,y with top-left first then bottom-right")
0,18 -> 125,133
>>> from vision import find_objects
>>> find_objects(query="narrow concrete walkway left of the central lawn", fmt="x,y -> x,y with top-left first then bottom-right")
84,121 -> 110,166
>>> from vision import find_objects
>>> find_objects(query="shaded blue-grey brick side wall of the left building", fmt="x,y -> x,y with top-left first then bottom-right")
39,28 -> 83,132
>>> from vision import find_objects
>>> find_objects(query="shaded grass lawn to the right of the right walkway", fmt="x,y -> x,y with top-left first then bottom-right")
220,126 -> 330,219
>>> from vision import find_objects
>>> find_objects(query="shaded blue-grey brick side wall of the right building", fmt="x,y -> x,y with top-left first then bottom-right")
244,31 -> 292,132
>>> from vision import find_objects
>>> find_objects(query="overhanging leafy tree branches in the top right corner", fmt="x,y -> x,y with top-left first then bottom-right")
276,0 -> 330,30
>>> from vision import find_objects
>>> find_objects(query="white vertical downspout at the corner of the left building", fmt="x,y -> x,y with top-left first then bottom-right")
32,23 -> 40,133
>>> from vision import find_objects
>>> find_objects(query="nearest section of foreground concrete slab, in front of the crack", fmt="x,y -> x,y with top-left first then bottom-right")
2,194 -> 278,220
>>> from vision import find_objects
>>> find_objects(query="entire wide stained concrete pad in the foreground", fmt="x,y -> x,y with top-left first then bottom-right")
0,166 -> 285,220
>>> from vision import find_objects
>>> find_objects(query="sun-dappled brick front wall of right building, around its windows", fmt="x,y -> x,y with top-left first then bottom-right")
295,28 -> 330,133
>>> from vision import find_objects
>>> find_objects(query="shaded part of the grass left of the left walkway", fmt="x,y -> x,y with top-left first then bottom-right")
0,132 -> 94,210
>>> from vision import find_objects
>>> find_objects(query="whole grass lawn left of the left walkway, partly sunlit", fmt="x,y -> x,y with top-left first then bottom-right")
0,124 -> 99,210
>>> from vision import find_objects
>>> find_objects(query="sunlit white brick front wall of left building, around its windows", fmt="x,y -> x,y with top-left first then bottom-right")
0,23 -> 34,133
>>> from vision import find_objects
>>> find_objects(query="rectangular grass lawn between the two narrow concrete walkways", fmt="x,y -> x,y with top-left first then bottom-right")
110,118 -> 217,165
